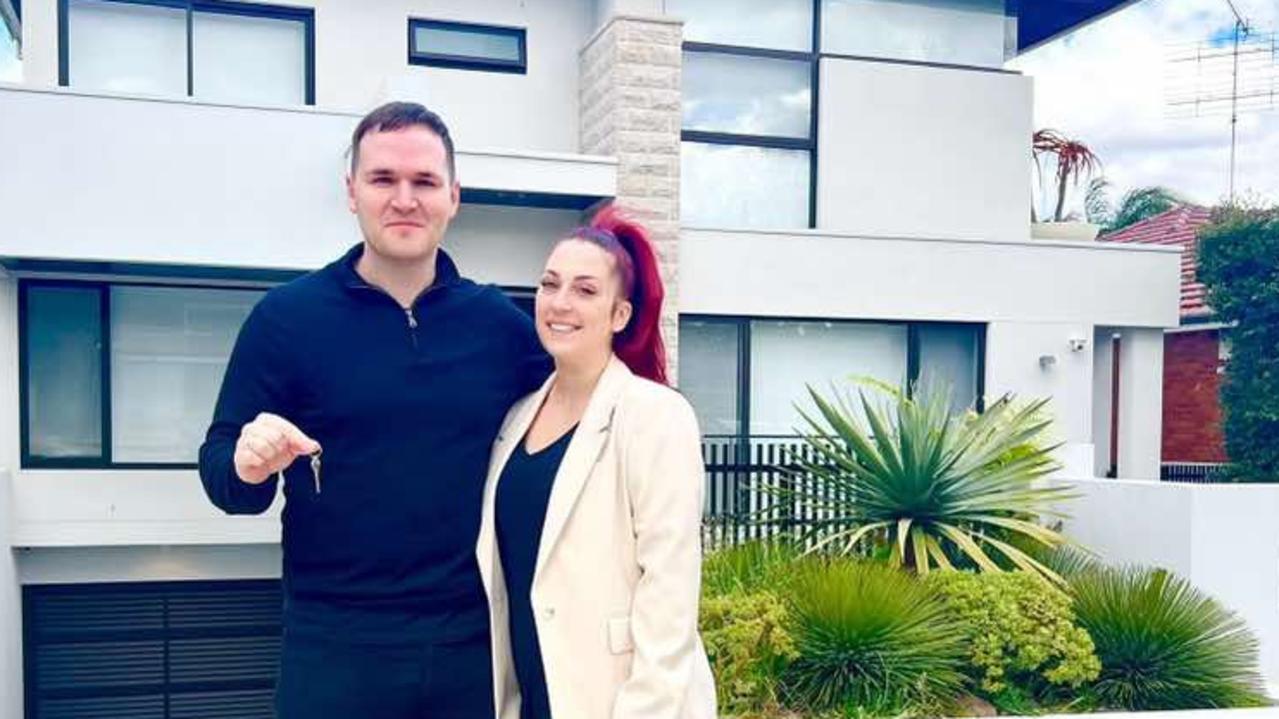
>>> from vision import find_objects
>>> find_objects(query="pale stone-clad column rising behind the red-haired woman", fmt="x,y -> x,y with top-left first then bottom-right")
579,14 -> 683,381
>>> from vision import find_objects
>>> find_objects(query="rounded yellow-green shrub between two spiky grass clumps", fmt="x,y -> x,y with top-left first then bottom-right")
927,572 -> 1101,705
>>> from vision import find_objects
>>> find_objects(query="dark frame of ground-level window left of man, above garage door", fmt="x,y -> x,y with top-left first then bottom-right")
18,278 -> 270,470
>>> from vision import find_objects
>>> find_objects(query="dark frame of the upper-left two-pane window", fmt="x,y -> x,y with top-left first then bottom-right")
58,0 -> 316,105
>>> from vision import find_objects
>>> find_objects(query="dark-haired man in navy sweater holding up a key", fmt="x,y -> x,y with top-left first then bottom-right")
200,102 -> 549,719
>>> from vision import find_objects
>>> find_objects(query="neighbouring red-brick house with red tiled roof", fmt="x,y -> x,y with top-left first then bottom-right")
1101,205 -> 1229,478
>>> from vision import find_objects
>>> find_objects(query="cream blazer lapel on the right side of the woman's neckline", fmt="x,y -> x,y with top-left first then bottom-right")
532,357 -> 632,581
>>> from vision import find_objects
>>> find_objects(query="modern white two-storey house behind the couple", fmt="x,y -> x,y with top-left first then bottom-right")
0,0 -> 1179,719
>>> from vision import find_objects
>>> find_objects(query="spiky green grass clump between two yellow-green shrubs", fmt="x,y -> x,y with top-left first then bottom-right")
784,559 -> 963,715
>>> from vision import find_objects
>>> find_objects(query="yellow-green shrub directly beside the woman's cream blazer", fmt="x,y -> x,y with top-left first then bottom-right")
701,591 -> 798,714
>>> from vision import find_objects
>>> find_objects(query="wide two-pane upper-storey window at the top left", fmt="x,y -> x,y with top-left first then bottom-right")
60,0 -> 315,105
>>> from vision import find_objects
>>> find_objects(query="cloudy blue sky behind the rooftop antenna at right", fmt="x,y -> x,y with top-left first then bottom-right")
1009,0 -> 1279,213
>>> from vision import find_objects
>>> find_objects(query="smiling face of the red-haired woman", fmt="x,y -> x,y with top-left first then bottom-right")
533,239 -> 631,363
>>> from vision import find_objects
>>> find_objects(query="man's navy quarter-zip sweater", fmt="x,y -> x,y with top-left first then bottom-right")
200,246 -> 550,644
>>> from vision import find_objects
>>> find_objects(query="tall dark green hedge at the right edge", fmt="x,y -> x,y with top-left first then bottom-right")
1198,207 -> 1279,482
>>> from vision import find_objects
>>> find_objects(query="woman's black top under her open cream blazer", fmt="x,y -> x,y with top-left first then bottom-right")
496,427 -> 576,719
